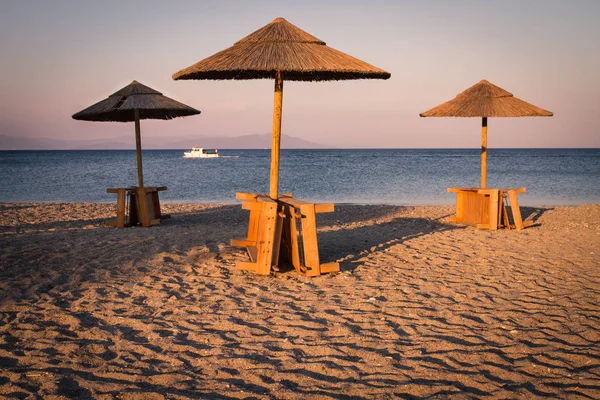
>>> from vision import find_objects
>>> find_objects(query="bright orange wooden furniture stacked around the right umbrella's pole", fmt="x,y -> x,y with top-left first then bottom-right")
448,187 -> 533,230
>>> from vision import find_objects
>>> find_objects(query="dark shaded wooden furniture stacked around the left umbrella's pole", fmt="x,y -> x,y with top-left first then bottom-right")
106,186 -> 171,228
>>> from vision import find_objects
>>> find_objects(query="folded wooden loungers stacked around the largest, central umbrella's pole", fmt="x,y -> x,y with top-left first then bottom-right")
231,193 -> 340,276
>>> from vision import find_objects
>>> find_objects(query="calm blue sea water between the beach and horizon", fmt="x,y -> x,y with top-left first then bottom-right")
0,149 -> 600,205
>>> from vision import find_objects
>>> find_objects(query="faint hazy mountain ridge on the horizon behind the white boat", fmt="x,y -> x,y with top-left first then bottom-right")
0,133 -> 330,150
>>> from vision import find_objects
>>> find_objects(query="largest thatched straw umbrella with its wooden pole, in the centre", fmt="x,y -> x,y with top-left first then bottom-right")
173,18 -> 390,199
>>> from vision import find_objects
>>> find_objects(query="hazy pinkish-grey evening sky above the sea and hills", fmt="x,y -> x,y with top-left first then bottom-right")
0,0 -> 600,148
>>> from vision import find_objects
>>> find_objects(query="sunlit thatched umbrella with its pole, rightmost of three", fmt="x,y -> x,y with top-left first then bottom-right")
419,80 -> 552,188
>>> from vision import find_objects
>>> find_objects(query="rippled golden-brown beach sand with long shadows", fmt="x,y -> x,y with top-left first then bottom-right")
0,203 -> 600,399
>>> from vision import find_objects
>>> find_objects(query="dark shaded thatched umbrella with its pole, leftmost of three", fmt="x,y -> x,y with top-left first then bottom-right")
73,81 -> 200,188
